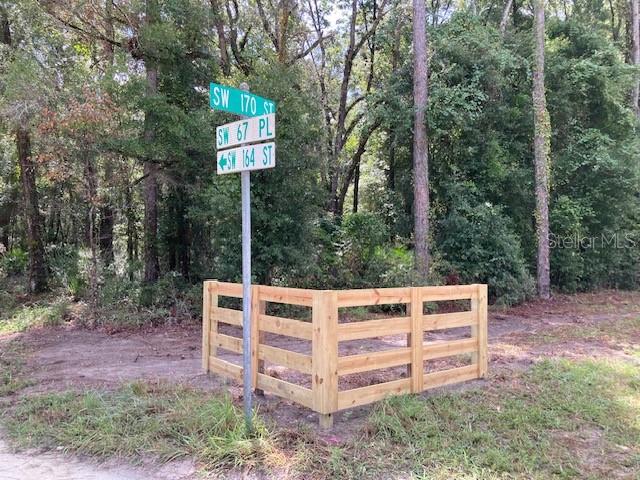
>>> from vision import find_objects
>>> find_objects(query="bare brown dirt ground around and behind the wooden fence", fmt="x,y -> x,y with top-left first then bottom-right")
0,291 -> 640,480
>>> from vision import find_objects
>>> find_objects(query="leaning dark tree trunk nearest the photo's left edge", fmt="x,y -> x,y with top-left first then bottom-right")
16,126 -> 47,293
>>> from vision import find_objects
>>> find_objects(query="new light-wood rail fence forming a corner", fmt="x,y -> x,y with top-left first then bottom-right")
202,281 -> 487,427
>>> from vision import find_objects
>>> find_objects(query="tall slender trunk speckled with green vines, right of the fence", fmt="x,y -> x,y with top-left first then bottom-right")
533,0 -> 551,299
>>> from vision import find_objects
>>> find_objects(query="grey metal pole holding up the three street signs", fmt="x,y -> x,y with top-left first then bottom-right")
240,83 -> 253,432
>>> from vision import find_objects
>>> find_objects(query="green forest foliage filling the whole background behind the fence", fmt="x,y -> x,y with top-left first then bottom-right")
0,0 -> 640,308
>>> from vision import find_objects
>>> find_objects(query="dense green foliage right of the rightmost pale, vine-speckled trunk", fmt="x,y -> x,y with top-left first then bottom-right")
547,22 -> 640,291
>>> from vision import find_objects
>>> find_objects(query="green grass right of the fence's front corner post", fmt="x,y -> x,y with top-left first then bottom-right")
306,361 -> 640,479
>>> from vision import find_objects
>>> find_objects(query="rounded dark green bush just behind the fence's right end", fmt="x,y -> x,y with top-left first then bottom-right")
436,202 -> 534,305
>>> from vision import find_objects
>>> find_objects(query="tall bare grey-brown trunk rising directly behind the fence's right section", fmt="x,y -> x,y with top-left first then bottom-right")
413,0 -> 429,280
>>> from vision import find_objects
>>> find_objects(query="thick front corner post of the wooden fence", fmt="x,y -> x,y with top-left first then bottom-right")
311,290 -> 338,428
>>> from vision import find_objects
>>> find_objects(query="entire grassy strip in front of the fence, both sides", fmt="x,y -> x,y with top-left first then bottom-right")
5,360 -> 640,480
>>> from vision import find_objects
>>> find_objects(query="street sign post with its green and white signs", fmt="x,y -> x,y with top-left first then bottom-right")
209,83 -> 276,431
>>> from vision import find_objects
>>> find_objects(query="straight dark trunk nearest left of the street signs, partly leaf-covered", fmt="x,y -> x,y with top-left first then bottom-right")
143,0 -> 160,283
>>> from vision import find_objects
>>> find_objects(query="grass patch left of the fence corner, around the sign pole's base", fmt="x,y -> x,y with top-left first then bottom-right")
5,383 -> 277,469
